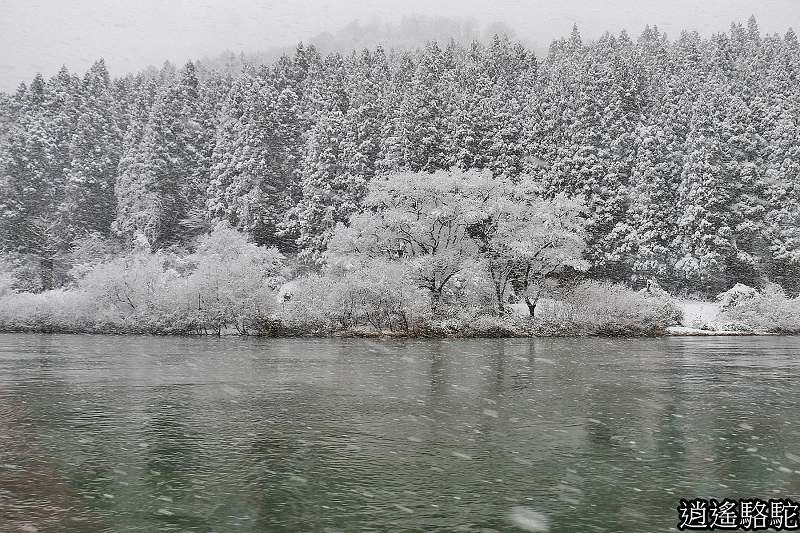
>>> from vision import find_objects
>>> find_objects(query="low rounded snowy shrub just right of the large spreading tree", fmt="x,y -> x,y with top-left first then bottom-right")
566,281 -> 681,335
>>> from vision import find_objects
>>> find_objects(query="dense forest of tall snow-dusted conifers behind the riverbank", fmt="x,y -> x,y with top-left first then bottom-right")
0,15 -> 800,293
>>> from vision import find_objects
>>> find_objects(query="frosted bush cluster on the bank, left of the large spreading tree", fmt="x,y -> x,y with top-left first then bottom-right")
0,223 -> 283,333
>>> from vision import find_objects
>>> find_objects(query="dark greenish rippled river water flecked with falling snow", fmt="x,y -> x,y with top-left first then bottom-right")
0,335 -> 800,532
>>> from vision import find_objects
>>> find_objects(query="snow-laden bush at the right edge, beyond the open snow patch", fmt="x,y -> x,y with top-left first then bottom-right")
719,283 -> 800,334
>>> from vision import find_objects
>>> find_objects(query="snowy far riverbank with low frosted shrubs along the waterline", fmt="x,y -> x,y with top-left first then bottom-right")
0,265 -> 800,338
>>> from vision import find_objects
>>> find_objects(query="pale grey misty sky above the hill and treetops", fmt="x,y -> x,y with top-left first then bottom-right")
0,0 -> 800,91
